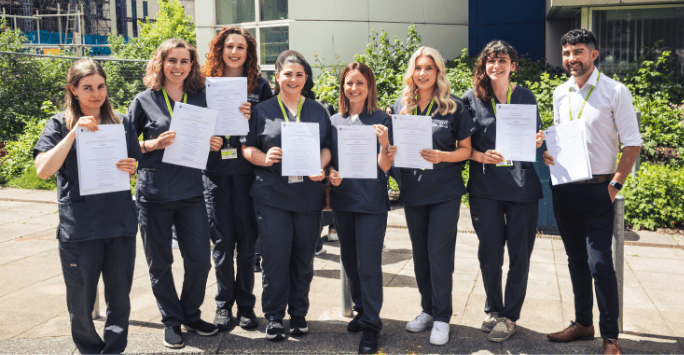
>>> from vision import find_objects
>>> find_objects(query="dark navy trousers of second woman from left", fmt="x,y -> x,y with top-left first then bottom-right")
138,196 -> 211,328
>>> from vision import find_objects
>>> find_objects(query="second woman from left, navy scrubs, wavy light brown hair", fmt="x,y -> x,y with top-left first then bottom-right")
128,39 -> 222,348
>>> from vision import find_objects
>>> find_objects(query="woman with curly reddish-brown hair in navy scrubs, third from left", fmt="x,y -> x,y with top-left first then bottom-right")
202,27 -> 273,330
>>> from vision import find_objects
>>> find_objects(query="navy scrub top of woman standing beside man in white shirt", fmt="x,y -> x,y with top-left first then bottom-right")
463,86 -> 544,202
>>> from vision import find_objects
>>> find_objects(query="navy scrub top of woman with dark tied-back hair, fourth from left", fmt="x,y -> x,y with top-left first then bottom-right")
244,96 -> 330,212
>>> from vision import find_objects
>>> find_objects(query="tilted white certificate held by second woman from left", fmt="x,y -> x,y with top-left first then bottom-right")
162,102 -> 218,169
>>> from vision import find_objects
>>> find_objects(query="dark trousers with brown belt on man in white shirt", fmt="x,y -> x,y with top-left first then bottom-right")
551,182 -> 620,339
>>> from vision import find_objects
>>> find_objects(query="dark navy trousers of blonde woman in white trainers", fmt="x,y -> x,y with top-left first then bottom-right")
404,198 -> 461,323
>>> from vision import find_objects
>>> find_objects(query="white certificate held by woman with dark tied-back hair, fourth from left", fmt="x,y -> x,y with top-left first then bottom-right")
281,122 -> 321,176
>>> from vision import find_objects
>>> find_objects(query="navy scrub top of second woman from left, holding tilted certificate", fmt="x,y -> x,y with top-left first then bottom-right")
128,89 -> 207,202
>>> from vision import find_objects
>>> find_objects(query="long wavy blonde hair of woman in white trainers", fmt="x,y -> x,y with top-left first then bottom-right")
400,47 -> 458,116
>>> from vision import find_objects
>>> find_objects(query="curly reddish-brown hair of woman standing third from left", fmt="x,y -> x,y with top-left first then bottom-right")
202,26 -> 261,94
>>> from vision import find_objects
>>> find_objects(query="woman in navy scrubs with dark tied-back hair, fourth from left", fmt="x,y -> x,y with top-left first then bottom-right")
242,51 -> 330,340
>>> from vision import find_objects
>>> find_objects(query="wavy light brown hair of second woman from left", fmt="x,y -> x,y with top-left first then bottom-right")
143,38 -> 204,94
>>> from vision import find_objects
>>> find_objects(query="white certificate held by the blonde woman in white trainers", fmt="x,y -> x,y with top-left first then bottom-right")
392,115 -> 432,169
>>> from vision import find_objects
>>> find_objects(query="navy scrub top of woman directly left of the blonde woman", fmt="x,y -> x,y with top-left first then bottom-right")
330,111 -> 392,213
